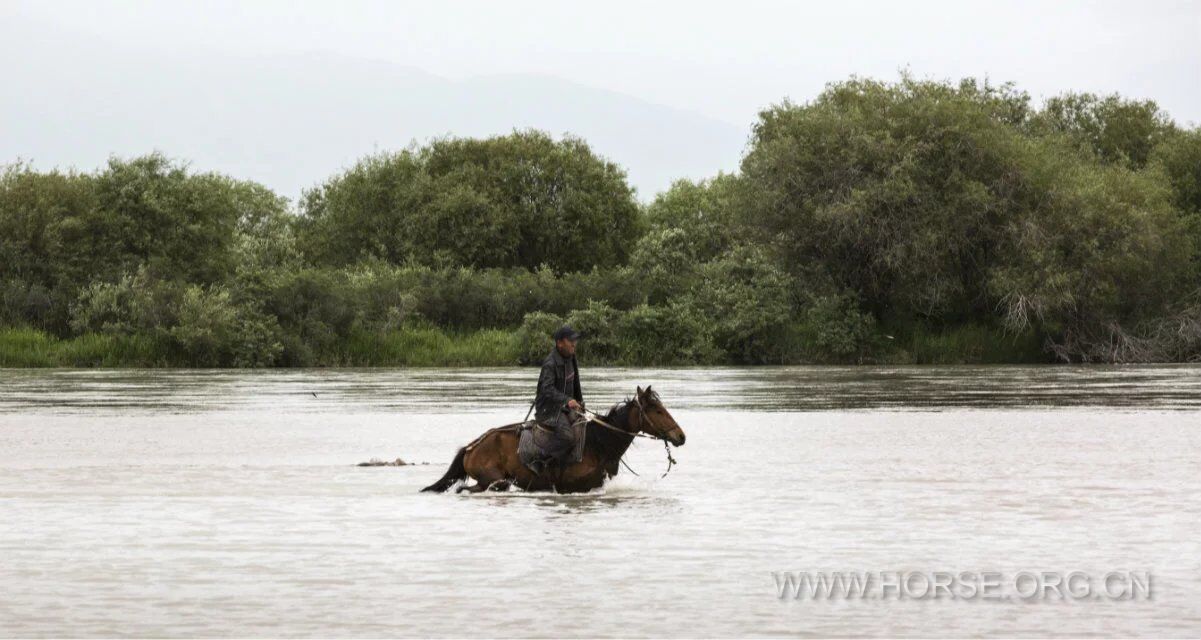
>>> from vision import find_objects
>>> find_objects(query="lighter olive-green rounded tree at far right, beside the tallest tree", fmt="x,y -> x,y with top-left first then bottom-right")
985,143 -> 1193,345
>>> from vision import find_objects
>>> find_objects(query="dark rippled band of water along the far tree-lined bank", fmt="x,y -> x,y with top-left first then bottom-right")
0,365 -> 1201,413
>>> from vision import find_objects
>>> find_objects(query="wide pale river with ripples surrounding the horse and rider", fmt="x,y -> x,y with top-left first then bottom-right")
0,365 -> 1201,638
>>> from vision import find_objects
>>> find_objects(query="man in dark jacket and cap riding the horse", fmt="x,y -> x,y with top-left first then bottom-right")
534,324 -> 585,472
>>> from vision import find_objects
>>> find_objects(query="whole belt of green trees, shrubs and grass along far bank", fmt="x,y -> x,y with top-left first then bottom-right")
0,77 -> 1201,366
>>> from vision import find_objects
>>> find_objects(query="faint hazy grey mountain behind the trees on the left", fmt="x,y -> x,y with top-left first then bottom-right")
0,22 -> 747,199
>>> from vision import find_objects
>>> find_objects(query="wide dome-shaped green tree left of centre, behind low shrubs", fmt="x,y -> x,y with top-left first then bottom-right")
299,131 -> 640,273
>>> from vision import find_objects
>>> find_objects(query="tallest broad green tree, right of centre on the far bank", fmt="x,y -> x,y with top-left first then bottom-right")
739,77 -> 1027,318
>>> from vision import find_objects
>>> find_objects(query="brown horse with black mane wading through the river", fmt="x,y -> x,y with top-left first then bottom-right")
422,387 -> 685,494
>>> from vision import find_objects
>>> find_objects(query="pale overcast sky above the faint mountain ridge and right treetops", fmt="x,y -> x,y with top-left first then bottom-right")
4,0 -> 1201,126
